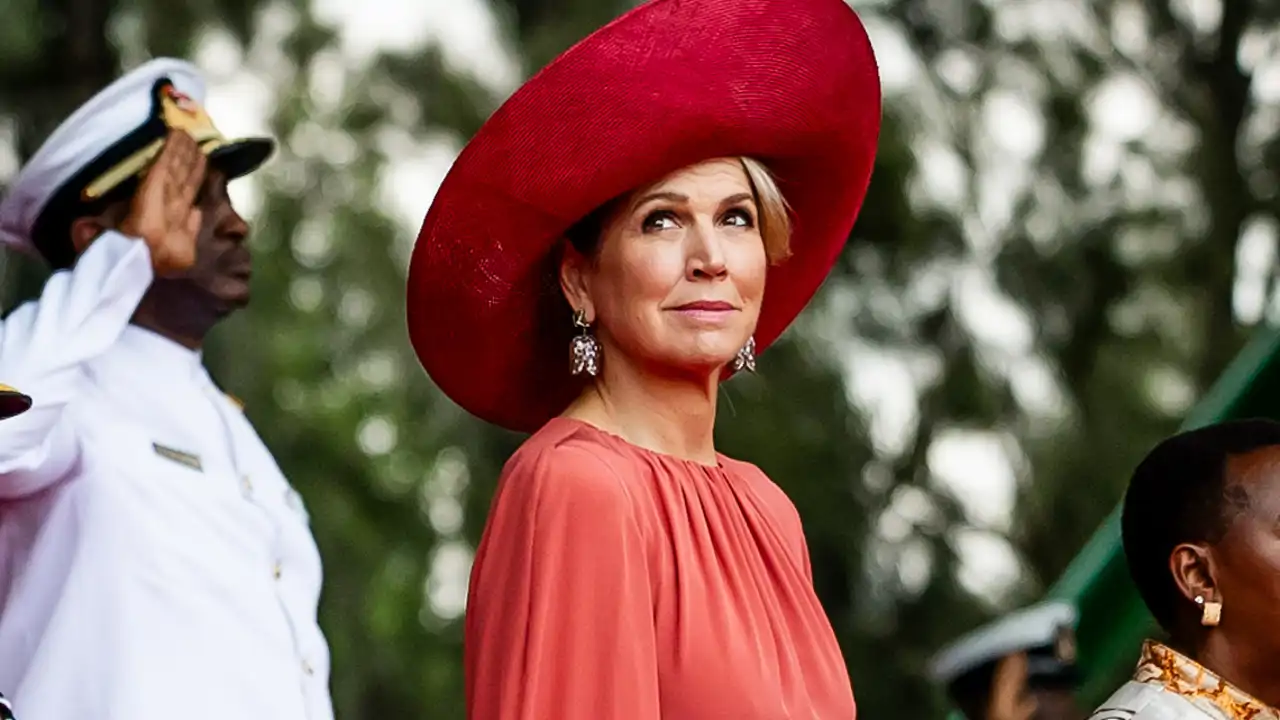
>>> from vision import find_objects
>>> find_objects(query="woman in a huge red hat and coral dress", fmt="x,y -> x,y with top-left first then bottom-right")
408,0 -> 881,720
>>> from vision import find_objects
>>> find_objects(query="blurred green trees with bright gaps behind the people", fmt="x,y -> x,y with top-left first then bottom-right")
0,0 -> 1280,720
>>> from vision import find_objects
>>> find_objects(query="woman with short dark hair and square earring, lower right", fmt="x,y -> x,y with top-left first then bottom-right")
1092,420 -> 1280,720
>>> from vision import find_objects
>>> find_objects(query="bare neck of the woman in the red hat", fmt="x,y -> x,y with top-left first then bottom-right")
566,360 -> 719,465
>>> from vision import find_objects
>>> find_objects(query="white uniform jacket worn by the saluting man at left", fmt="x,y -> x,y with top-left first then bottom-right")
0,233 -> 333,720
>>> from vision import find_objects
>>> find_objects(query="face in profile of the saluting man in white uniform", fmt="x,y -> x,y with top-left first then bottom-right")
155,165 -> 252,316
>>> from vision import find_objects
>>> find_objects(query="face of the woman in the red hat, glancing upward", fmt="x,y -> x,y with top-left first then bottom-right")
561,159 -> 768,374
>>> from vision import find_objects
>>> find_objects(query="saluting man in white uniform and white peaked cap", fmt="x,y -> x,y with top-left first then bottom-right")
0,59 -> 333,720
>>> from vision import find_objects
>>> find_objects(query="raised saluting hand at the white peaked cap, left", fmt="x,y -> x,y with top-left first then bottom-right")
120,129 -> 207,275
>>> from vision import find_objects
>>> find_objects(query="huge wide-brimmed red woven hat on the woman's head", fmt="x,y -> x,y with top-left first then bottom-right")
407,0 -> 881,430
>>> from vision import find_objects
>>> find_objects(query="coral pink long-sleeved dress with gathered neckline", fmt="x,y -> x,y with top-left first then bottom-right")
466,418 -> 855,720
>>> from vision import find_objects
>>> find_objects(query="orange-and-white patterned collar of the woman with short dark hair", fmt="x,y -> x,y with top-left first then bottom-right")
1133,641 -> 1280,720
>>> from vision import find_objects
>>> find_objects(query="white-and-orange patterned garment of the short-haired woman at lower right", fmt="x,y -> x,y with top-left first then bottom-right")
1089,641 -> 1280,720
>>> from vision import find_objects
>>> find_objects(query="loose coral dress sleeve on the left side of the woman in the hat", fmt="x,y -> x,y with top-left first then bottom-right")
466,445 -> 660,720
